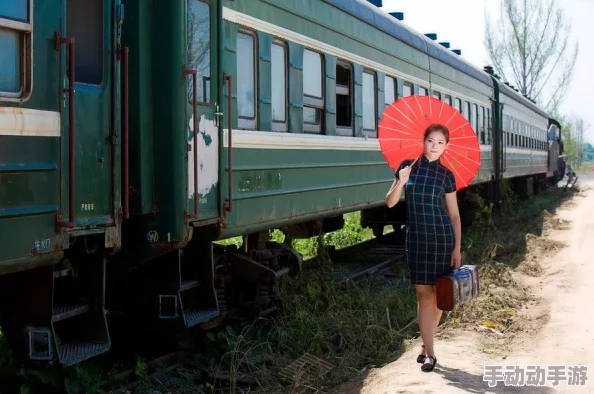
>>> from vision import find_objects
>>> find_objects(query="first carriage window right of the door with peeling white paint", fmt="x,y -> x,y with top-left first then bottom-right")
237,31 -> 256,129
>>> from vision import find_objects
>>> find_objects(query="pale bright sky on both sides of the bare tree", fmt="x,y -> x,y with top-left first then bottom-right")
382,0 -> 594,144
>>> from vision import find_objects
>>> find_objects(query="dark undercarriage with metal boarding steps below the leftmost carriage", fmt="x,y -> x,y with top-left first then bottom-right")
0,253 -> 111,366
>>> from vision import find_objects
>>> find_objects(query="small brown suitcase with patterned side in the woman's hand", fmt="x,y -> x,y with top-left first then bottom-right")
435,265 -> 479,311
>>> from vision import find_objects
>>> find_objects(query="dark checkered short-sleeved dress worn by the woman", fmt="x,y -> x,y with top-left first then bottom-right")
395,155 -> 456,285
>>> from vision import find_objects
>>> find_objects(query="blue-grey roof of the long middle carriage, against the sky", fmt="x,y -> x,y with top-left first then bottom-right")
324,0 -> 493,86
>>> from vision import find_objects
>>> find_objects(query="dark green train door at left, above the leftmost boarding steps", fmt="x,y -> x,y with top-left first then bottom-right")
56,0 -> 121,227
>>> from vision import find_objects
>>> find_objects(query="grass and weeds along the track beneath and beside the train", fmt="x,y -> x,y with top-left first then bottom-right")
0,182 -> 579,394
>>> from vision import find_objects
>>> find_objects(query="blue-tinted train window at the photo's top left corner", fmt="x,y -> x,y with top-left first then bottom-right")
0,0 -> 33,99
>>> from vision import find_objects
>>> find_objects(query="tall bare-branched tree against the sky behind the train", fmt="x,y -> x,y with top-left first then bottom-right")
485,0 -> 578,111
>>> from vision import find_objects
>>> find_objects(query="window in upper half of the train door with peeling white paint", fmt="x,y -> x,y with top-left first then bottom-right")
186,0 -> 212,106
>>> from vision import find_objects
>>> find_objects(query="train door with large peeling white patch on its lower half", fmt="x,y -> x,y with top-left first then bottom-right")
183,0 -> 222,220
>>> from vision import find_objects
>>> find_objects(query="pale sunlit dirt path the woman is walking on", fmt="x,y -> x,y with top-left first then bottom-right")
337,179 -> 594,394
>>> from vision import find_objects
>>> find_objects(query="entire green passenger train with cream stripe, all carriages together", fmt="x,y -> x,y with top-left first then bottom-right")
0,0 -> 562,366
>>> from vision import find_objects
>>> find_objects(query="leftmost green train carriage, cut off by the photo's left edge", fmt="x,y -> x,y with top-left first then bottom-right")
0,0 -> 122,365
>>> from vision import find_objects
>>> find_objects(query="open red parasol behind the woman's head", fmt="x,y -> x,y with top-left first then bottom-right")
378,95 -> 481,190
